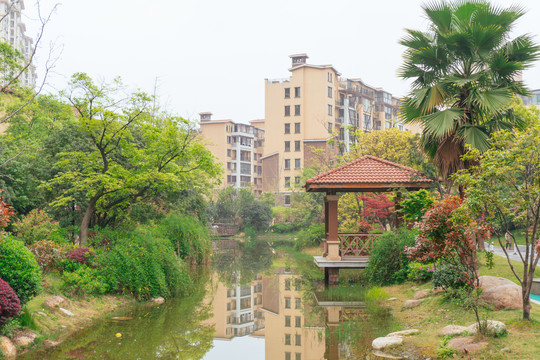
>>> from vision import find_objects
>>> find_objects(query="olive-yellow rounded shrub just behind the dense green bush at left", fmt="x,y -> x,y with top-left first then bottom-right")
13,209 -> 60,245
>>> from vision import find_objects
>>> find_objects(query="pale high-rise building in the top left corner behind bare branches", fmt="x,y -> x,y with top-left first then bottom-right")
0,0 -> 37,88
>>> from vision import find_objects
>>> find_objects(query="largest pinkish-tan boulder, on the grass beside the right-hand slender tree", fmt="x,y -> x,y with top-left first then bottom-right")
480,276 -> 523,310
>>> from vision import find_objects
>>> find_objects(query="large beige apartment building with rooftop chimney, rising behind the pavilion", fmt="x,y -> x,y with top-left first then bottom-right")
262,54 -> 420,205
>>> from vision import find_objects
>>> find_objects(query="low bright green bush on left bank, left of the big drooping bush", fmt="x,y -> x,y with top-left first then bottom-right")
62,265 -> 109,295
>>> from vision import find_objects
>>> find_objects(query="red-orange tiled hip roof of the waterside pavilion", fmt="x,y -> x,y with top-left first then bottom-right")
304,155 -> 432,192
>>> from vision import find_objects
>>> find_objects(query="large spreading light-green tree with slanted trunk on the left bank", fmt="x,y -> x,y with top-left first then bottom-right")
46,73 -> 220,244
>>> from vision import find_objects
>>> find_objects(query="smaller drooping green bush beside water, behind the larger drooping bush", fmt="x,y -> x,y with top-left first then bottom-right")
157,213 -> 212,264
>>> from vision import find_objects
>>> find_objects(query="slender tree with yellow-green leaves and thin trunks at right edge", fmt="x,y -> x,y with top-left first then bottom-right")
457,119 -> 540,320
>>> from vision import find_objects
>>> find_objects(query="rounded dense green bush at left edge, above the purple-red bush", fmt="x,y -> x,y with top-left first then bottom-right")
0,236 -> 41,305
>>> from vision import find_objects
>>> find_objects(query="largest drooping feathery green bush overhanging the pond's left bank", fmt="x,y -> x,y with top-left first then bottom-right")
96,232 -> 191,300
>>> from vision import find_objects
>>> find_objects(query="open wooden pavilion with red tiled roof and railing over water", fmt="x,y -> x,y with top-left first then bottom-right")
304,155 -> 433,286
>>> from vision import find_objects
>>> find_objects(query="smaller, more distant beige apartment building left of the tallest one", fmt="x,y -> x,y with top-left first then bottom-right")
199,112 -> 265,194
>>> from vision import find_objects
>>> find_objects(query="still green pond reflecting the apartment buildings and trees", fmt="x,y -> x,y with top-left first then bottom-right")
20,242 -> 392,360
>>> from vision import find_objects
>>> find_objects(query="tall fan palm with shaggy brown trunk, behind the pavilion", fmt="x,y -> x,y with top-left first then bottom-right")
399,0 -> 540,183
